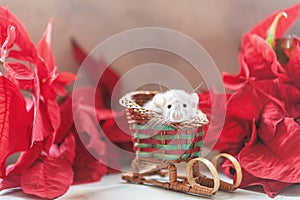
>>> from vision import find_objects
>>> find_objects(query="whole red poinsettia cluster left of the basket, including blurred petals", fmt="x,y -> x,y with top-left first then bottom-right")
0,7 -> 131,199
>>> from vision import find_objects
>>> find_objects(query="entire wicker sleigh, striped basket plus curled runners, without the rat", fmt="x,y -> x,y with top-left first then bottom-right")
120,91 -> 242,196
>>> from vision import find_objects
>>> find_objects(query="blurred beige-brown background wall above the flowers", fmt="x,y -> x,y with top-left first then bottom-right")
0,0 -> 300,90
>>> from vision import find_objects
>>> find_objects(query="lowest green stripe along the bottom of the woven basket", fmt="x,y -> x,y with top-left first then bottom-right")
136,151 -> 200,161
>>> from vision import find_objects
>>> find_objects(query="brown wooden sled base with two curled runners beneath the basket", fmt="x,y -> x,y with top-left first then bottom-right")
122,154 -> 242,196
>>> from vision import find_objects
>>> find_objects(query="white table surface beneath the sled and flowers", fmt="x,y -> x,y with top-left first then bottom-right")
0,170 -> 300,200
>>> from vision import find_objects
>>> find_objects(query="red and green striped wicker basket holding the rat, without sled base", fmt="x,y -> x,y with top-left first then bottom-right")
120,91 -> 208,163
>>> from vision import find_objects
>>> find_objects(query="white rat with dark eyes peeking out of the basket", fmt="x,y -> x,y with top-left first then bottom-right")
143,89 -> 207,122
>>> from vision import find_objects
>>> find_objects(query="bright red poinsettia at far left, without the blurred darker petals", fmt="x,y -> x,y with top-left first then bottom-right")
0,8 -> 75,198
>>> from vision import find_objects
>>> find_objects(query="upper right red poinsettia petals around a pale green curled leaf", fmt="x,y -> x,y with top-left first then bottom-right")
223,5 -> 300,90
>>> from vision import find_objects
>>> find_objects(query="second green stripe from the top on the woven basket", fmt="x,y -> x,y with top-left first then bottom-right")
133,132 -> 204,140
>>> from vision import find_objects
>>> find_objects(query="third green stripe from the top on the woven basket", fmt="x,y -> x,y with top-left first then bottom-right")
134,141 -> 203,150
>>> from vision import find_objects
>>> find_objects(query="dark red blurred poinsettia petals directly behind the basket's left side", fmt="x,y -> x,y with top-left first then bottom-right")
72,39 -> 133,156
